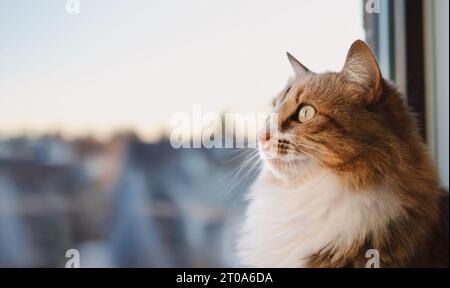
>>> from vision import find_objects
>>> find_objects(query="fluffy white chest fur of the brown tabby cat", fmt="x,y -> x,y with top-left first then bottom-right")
238,166 -> 402,267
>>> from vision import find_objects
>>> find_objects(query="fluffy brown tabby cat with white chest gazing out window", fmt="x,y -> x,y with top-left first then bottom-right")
238,40 -> 449,268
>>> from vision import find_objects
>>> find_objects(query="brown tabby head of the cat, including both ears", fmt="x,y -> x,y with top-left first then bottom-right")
259,40 -> 390,181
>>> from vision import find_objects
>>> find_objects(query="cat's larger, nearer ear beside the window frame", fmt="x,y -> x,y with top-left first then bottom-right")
342,40 -> 383,103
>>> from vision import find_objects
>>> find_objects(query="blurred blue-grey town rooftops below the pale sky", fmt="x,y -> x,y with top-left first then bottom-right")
0,133 -> 258,267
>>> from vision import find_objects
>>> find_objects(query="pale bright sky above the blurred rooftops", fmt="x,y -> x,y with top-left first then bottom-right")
0,0 -> 365,138
